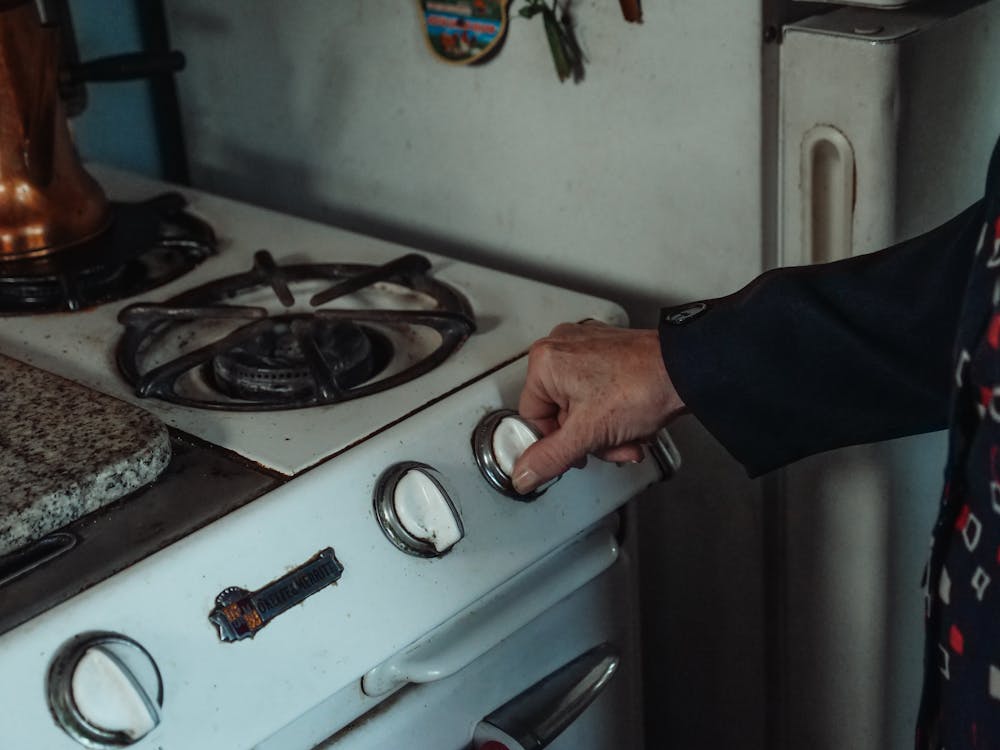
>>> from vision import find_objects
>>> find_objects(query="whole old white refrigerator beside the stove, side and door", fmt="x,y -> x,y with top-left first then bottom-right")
71,0 -> 1000,750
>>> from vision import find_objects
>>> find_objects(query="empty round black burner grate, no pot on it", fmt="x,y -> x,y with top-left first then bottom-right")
118,250 -> 475,411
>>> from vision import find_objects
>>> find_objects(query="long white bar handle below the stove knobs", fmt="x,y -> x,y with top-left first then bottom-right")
361,519 -> 619,696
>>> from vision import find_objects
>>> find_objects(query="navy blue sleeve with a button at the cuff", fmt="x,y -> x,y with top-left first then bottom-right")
660,203 -> 984,476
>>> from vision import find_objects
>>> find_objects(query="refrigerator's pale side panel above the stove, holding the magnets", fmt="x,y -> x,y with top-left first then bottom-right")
167,0 -> 761,324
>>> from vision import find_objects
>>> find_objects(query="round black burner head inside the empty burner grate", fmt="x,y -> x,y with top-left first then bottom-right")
211,316 -> 392,403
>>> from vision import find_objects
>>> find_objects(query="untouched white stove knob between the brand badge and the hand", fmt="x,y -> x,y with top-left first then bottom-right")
375,461 -> 465,557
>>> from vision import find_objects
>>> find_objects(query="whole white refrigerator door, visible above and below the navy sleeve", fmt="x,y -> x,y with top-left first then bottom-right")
776,0 -> 1000,750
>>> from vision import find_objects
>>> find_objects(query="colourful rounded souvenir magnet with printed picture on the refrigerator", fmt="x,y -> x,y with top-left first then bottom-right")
420,0 -> 510,65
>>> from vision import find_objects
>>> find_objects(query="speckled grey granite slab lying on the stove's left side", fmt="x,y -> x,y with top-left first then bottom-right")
0,355 -> 170,554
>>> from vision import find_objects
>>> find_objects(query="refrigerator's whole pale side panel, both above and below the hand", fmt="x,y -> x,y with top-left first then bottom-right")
166,0 -> 765,750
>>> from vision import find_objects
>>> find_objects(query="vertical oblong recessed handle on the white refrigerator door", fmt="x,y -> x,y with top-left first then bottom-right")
802,125 -> 855,263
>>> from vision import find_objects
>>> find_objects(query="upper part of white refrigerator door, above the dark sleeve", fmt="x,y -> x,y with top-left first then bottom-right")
779,0 -> 1000,265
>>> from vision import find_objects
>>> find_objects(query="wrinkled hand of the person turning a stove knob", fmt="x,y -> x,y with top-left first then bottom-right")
511,322 -> 684,494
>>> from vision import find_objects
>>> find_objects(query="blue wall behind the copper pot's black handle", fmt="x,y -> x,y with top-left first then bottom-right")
70,0 -> 163,177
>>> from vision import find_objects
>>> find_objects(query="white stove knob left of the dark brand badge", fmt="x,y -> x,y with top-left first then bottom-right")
48,633 -> 163,748
